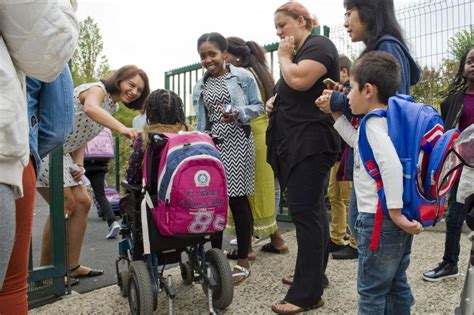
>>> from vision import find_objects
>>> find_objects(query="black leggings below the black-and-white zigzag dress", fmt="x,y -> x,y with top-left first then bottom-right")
212,196 -> 253,259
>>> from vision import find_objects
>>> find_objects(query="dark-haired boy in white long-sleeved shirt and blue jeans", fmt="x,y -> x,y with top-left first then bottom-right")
317,51 -> 422,314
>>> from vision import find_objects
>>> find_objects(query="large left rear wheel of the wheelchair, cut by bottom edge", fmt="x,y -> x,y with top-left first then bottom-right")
128,260 -> 156,315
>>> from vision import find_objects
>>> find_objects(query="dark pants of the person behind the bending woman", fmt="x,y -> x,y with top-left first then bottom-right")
84,160 -> 115,226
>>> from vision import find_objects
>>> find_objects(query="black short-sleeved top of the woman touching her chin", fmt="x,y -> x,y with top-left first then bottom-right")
267,35 -> 339,187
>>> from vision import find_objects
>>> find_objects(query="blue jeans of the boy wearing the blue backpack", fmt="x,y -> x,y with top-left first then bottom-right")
356,212 -> 414,315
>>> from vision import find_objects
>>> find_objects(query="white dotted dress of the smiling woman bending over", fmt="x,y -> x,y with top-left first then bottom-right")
36,82 -> 118,187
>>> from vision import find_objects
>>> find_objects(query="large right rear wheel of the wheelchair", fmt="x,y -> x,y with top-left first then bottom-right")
202,248 -> 234,310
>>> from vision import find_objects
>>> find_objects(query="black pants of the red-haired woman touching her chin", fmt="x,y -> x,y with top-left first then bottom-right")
285,153 -> 336,307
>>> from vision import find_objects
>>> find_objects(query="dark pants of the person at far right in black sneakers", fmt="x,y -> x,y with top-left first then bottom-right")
443,181 -> 467,264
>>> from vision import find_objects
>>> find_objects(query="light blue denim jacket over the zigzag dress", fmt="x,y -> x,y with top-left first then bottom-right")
193,65 -> 263,131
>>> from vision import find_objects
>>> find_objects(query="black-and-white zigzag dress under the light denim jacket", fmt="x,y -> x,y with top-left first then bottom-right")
203,73 -> 255,197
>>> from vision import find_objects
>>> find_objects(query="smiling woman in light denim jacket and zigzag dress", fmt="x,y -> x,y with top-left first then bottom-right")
193,33 -> 263,284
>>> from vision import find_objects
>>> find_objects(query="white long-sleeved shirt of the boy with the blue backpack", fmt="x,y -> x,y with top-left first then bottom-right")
334,111 -> 403,213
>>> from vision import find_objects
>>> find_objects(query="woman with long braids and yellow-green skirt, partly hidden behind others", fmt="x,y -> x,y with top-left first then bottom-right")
226,36 -> 288,258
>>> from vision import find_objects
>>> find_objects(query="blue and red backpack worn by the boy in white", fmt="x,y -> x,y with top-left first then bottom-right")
359,94 -> 460,250
